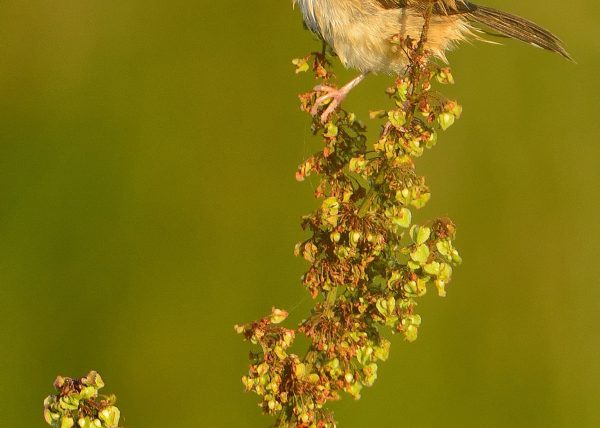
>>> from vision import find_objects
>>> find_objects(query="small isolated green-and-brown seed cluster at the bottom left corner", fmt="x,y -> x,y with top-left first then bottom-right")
44,371 -> 121,428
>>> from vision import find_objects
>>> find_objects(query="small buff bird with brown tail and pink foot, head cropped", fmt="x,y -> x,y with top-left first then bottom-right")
293,0 -> 573,122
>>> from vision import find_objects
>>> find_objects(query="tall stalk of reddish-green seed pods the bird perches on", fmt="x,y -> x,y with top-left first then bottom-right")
235,9 -> 461,428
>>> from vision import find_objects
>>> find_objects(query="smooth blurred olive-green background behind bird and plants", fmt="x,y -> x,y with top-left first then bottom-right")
0,0 -> 600,428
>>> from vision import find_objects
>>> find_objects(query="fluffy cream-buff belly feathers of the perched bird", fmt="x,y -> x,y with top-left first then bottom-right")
296,0 -> 470,73
